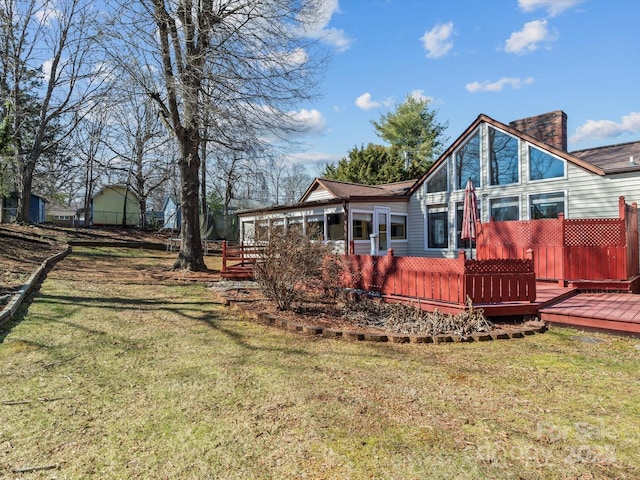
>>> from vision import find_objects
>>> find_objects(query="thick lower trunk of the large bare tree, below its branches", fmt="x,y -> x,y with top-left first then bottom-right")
173,129 -> 207,271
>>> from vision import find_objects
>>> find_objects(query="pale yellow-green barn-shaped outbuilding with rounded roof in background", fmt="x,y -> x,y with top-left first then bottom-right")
91,185 -> 140,226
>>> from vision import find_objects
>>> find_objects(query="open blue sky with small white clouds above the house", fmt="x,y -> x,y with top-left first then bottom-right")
291,0 -> 640,176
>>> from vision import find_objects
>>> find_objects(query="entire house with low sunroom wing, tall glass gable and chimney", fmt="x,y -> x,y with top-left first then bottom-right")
238,110 -> 640,258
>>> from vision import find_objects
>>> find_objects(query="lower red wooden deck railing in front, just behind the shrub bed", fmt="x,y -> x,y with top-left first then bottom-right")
342,250 -> 536,305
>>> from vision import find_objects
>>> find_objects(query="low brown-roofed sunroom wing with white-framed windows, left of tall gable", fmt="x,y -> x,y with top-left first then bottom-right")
238,179 -> 414,255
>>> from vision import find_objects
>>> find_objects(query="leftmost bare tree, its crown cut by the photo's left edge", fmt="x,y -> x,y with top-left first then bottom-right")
0,0 -> 107,222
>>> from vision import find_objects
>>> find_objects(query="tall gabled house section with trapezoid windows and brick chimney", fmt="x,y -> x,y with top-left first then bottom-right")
409,110 -> 640,257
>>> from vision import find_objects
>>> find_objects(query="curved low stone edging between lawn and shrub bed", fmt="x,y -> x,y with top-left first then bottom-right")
213,291 -> 547,343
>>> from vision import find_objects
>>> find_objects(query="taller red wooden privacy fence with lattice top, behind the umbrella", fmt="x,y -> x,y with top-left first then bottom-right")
476,197 -> 640,283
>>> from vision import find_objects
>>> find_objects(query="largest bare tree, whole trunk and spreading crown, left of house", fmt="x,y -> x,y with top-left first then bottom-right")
105,0 -> 324,270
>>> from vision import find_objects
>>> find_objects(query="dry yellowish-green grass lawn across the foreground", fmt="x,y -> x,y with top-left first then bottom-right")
0,248 -> 640,480
